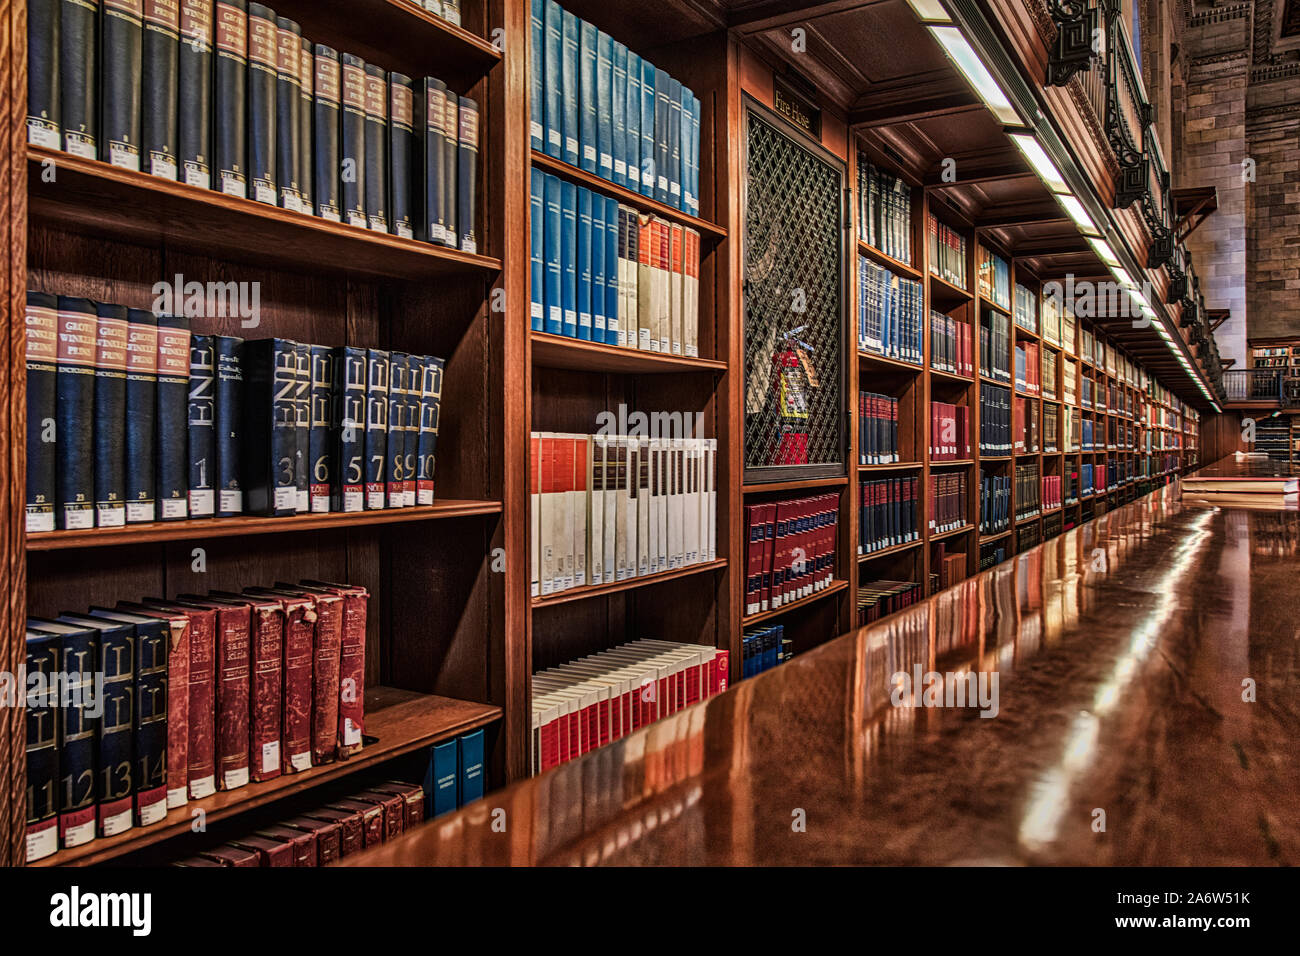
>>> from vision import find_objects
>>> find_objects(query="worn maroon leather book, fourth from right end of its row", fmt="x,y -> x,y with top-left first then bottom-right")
211,591 -> 285,783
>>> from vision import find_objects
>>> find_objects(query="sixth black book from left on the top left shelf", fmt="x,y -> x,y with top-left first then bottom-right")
212,0 -> 248,198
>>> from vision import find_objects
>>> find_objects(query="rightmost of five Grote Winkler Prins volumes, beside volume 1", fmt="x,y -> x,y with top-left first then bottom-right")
155,315 -> 190,522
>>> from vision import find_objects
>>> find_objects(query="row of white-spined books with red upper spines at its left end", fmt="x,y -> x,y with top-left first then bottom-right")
529,432 -> 718,597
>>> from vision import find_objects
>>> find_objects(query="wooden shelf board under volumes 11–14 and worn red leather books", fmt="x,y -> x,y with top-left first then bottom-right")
33,687 -> 502,866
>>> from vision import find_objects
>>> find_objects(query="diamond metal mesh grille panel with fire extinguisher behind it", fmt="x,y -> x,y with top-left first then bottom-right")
745,112 -> 845,477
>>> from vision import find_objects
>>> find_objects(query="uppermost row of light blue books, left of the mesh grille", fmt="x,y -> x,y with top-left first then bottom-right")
529,0 -> 699,216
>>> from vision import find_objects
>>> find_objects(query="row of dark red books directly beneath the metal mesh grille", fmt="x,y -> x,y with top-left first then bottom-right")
745,494 -> 840,614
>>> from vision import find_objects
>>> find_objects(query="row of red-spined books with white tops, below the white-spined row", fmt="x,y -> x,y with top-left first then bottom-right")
532,640 -> 729,774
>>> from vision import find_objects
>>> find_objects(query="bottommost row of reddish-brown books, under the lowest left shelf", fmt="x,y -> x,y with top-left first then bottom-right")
173,780 -> 425,866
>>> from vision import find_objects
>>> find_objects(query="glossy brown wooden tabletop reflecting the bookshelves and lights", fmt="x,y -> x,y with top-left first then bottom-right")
351,463 -> 1300,865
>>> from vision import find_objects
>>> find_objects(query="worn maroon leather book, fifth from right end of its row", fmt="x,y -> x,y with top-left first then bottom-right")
181,594 -> 252,790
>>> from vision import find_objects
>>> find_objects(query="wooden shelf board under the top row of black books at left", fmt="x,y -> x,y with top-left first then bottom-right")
27,146 -> 502,280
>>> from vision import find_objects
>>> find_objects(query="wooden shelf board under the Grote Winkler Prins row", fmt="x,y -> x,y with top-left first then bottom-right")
27,498 -> 502,551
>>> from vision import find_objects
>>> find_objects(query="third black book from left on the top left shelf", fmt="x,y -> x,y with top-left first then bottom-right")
99,0 -> 144,169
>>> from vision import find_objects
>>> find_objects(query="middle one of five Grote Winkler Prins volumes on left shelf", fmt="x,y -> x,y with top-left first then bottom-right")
95,303 -> 129,528
